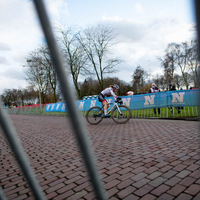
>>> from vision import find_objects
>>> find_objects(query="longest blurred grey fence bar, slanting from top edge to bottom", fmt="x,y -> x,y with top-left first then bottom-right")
34,0 -> 107,200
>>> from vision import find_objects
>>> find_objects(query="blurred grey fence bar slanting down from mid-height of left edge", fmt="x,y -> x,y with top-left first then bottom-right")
0,100 -> 45,200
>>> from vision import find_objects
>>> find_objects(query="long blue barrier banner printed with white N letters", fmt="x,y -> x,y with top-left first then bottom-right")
45,89 -> 199,112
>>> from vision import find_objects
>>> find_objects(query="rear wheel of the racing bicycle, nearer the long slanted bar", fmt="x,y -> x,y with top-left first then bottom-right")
86,107 -> 103,125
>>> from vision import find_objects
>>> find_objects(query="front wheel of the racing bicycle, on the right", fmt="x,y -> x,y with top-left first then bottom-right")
112,105 -> 131,124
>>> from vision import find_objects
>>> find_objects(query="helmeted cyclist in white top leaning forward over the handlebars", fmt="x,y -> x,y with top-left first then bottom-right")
98,84 -> 119,117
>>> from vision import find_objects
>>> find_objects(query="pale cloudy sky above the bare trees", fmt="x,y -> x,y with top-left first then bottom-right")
0,0 -> 196,94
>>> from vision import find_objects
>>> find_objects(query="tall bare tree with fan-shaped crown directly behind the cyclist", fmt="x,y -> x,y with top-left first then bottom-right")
77,24 -> 122,90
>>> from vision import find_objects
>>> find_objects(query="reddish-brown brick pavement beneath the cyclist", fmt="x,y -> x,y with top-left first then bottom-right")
0,115 -> 200,200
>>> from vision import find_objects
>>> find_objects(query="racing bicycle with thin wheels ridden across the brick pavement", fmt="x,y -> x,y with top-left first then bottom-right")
86,97 -> 131,125
